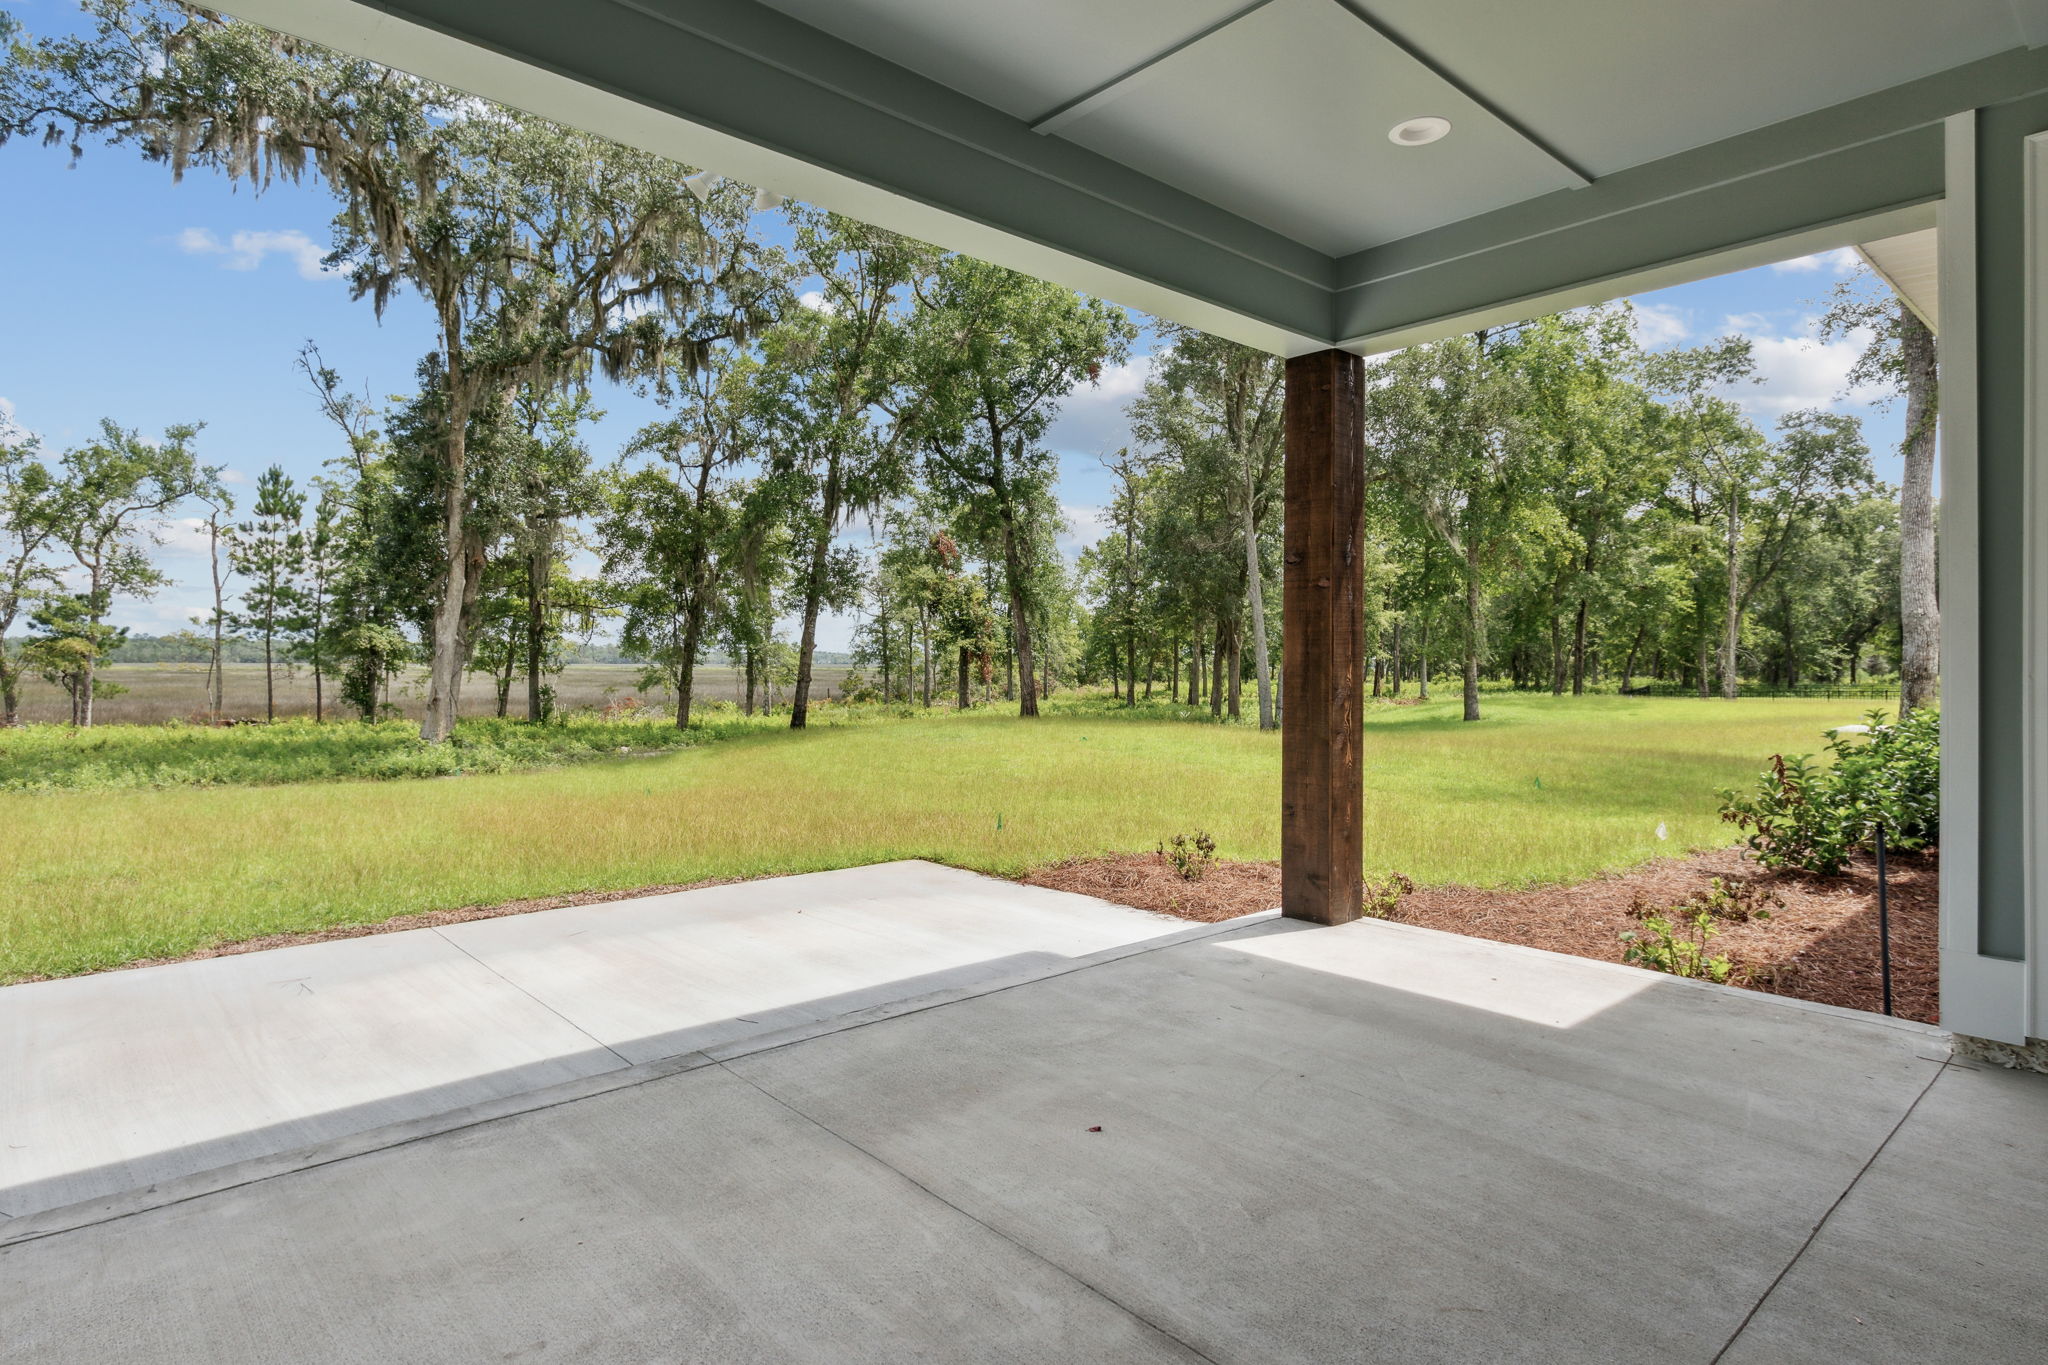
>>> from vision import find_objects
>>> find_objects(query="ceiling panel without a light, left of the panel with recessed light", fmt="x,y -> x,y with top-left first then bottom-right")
766,0 -> 1251,121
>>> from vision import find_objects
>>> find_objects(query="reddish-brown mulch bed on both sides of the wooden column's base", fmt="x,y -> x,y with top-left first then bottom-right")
1024,849 -> 1942,1023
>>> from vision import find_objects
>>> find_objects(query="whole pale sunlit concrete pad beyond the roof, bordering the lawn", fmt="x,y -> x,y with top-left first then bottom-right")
0,862 -> 1186,1218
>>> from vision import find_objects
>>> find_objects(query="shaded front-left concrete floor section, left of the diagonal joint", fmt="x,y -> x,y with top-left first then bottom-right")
0,1070 -> 1198,1365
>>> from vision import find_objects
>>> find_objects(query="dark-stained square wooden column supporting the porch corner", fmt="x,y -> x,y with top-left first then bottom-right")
1280,350 -> 1366,925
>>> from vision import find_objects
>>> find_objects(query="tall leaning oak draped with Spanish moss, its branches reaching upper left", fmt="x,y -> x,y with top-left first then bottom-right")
0,0 -> 780,741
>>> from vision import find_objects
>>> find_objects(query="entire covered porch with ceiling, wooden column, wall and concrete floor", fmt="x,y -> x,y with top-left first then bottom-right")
0,0 -> 2048,1363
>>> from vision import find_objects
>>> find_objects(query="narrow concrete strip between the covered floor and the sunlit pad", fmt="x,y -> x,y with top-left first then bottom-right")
0,911 -> 1280,1246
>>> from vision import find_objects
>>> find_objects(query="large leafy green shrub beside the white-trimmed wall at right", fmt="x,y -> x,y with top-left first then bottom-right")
1720,708 -> 1942,876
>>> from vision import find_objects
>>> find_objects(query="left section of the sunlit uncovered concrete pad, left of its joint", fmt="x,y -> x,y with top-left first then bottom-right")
0,929 -> 621,1216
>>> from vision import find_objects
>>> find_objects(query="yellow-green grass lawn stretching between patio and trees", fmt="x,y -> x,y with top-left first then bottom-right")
0,694 -> 1858,980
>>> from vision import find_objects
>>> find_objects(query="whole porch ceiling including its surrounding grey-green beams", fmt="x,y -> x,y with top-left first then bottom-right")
231,0 -> 2048,354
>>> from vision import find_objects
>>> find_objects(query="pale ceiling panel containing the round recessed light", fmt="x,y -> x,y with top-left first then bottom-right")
1040,0 -> 1577,254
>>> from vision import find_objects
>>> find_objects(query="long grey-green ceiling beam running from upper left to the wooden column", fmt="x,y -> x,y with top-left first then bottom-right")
231,0 -> 1331,354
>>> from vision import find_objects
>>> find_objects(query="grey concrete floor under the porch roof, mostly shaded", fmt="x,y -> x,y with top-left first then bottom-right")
0,921 -> 2048,1365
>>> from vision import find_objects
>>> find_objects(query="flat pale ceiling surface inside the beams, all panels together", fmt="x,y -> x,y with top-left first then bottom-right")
766,0 -> 2048,256
